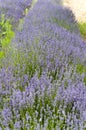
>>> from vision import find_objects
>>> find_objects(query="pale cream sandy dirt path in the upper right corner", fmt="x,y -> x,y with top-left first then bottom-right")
63,0 -> 86,22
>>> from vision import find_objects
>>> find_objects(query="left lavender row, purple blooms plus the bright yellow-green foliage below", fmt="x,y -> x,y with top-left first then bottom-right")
0,0 -> 32,57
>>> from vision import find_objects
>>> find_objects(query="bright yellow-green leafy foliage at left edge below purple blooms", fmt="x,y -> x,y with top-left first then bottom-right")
0,15 -> 14,58
